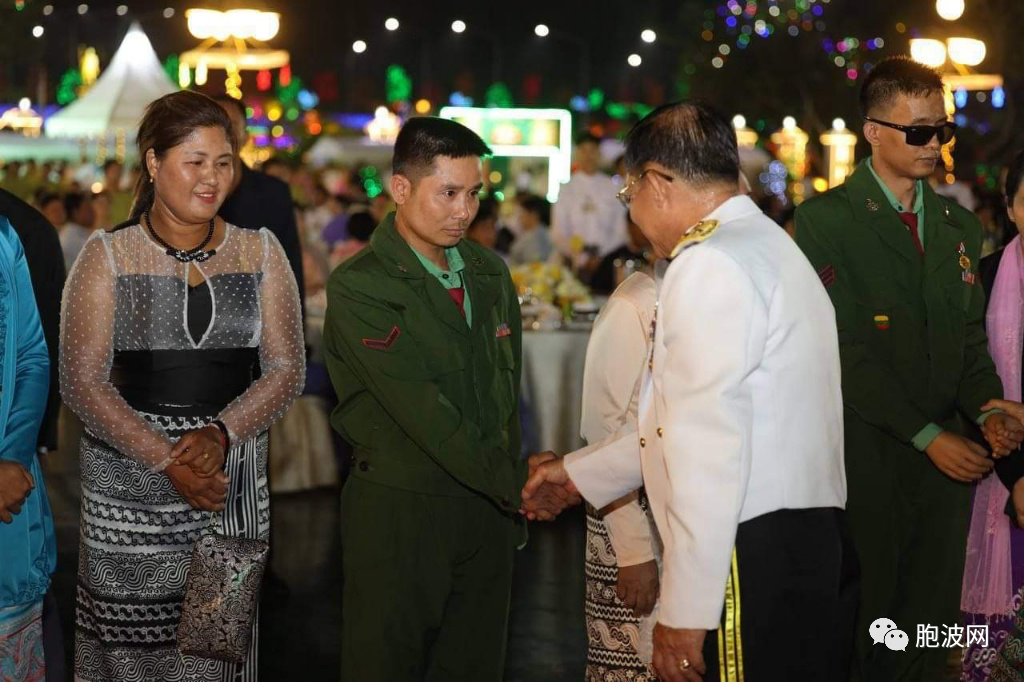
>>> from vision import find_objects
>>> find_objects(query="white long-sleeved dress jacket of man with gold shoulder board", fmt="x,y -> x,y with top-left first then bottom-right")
565,191 -> 846,630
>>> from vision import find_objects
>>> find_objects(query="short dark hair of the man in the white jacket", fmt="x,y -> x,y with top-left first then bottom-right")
626,101 -> 739,185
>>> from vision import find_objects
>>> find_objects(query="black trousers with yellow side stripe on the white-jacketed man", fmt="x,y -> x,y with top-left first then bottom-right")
703,508 -> 857,682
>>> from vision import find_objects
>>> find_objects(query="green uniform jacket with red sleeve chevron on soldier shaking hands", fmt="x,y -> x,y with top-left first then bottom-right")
324,214 -> 526,515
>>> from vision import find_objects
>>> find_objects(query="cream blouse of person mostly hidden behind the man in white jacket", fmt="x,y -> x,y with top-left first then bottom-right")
580,272 -> 657,566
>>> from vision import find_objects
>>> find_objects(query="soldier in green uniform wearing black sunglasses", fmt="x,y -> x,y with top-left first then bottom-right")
796,57 -> 1022,682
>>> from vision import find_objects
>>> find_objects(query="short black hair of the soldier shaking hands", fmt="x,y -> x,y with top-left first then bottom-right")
391,116 -> 490,180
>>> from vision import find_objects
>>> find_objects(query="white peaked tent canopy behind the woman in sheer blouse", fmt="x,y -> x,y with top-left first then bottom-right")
45,22 -> 178,138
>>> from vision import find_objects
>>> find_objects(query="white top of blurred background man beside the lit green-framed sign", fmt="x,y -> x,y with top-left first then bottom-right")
551,171 -> 626,258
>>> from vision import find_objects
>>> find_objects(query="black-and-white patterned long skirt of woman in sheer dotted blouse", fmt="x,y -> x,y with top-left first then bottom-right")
75,415 -> 270,682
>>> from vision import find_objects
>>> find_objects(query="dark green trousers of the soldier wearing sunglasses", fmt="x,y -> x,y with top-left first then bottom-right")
846,447 -> 971,682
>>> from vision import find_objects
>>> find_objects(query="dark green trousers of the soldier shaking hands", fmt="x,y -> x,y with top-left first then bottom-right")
341,476 -> 516,682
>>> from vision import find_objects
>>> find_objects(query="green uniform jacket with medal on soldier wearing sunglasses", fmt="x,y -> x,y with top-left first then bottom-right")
796,162 -> 1002,450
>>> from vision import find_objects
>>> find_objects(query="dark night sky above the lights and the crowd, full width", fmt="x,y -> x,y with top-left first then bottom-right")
0,0 -> 1024,155
